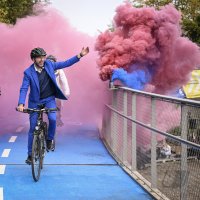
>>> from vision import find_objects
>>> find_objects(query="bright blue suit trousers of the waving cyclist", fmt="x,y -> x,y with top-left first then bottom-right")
28,97 -> 56,155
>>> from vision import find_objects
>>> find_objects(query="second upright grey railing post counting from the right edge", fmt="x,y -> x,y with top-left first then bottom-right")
151,98 -> 157,188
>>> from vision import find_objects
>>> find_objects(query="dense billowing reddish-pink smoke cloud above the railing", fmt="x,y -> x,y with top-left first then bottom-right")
95,3 -> 200,93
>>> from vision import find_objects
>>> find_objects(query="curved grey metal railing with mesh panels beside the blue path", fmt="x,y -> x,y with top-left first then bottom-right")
101,87 -> 200,200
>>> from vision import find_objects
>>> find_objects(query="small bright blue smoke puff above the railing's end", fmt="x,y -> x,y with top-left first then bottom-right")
111,68 -> 151,90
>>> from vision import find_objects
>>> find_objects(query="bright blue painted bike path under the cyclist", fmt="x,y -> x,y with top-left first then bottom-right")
0,124 -> 152,200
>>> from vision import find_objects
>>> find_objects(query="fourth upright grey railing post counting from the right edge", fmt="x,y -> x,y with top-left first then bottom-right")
122,91 -> 127,163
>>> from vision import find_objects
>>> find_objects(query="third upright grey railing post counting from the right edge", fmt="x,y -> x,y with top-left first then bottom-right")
132,93 -> 137,171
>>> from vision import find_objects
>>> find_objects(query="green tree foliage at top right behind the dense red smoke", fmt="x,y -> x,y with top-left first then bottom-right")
130,0 -> 200,44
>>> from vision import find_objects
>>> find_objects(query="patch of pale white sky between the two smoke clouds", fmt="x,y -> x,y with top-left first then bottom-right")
51,0 -> 124,36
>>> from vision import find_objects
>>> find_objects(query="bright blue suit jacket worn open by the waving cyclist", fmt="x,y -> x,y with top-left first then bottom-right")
18,56 -> 79,106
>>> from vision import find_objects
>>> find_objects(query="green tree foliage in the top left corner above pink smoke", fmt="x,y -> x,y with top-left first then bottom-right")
0,0 -> 49,25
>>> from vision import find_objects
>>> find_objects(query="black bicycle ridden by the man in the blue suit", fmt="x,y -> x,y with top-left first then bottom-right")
17,105 -> 57,182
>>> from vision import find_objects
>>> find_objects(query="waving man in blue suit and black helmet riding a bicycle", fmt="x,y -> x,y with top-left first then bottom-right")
17,47 -> 89,164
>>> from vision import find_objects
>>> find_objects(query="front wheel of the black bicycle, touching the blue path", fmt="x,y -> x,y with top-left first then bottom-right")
31,135 -> 41,182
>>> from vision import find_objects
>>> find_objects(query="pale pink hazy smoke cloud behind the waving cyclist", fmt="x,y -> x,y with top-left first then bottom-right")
0,9 -> 106,132
